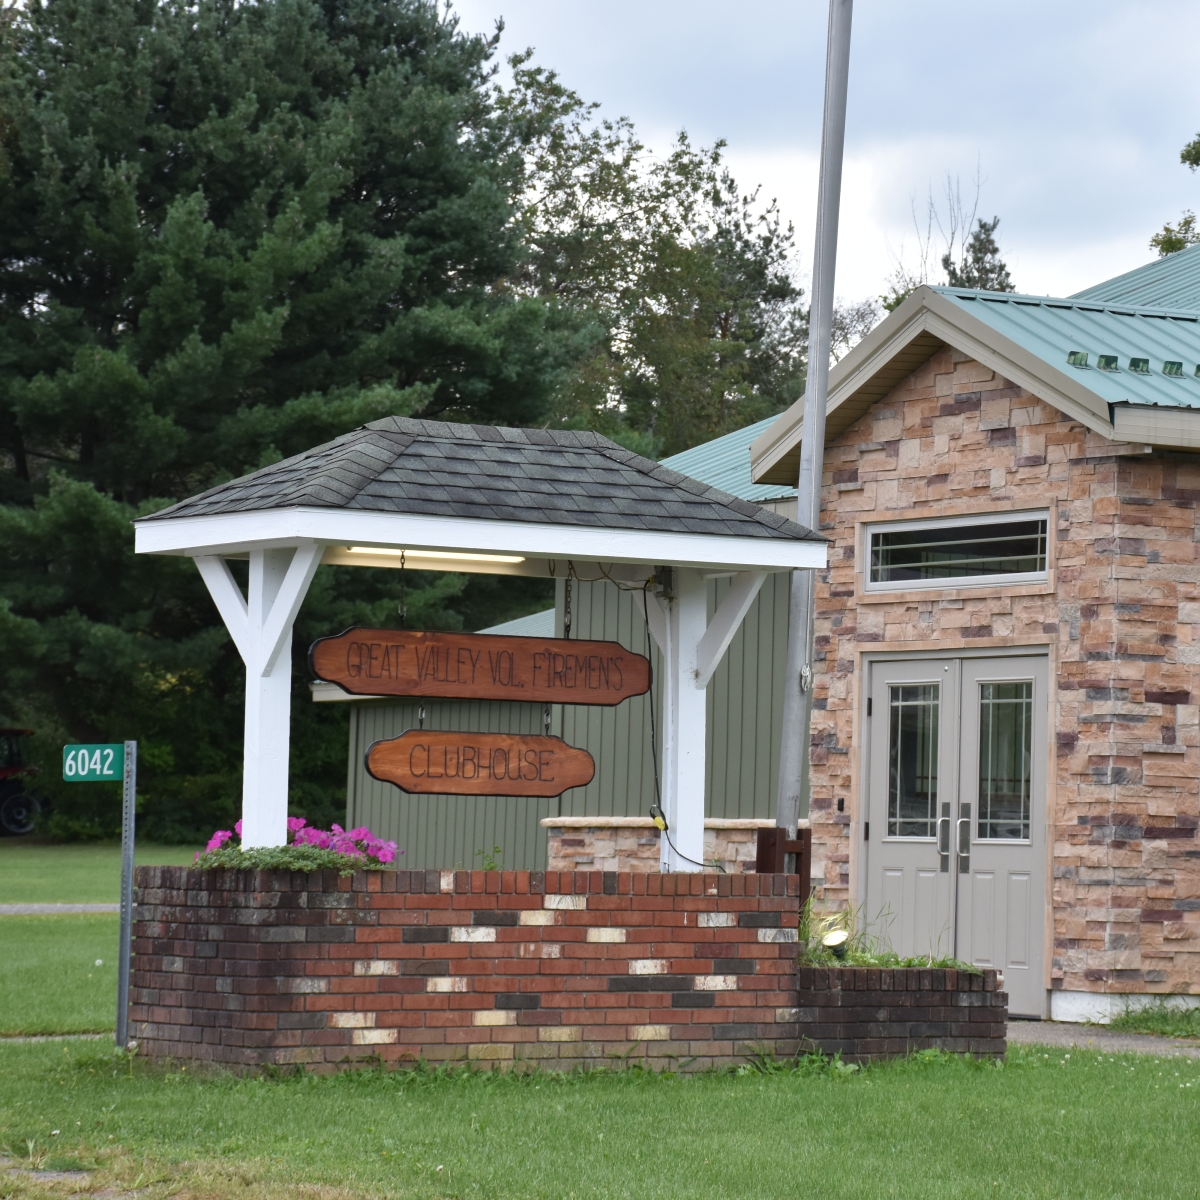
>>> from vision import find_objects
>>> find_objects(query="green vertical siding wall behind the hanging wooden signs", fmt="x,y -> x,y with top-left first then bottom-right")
348,574 -> 790,870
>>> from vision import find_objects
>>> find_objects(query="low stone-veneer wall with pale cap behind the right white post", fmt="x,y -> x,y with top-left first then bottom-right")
541,817 -> 772,874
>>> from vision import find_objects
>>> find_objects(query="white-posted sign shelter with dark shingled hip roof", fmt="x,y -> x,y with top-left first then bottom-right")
137,416 -> 826,870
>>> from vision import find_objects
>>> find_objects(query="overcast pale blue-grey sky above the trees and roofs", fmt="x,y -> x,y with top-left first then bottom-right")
455,0 -> 1200,300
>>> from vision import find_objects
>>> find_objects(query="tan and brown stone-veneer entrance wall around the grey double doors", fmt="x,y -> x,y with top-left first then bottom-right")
810,349 -> 1200,992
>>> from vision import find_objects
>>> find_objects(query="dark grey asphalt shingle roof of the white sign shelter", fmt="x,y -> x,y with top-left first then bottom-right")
144,416 -> 823,541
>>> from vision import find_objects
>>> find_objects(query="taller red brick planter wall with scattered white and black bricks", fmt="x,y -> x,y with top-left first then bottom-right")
131,866 -> 799,1067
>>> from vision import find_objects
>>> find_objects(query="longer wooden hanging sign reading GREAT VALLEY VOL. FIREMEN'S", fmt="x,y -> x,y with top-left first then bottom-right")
308,629 -> 650,700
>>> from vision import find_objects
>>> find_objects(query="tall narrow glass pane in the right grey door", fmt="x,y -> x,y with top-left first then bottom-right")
979,682 -> 1033,839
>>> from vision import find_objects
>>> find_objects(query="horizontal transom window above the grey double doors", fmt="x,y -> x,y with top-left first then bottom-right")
871,517 -> 1046,583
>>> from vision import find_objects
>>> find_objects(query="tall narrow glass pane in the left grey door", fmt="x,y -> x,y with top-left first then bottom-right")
888,683 -> 940,838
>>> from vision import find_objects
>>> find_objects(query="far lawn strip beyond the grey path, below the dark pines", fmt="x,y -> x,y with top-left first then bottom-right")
0,838 -> 198,904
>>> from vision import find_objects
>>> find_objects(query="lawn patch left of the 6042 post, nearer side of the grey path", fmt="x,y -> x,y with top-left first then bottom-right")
0,913 -> 120,1037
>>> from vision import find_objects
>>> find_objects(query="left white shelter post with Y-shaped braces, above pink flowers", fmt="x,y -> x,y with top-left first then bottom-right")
196,542 -> 323,848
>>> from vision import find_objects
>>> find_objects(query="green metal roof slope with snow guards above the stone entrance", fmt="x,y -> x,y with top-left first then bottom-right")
932,286 -> 1200,408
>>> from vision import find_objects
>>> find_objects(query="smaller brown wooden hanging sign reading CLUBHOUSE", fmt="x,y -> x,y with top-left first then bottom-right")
367,730 -> 596,796
